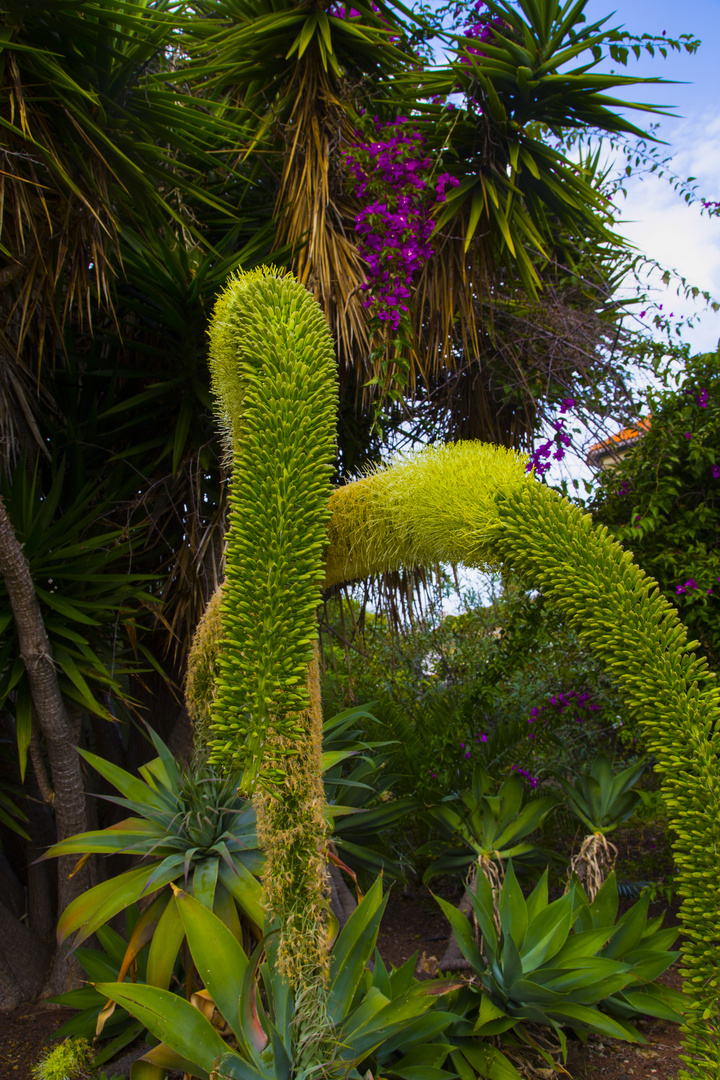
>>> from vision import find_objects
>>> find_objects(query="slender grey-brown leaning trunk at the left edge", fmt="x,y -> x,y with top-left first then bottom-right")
0,498 -> 90,993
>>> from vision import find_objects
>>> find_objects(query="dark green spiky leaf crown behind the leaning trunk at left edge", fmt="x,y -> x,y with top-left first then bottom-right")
0,457 -> 154,777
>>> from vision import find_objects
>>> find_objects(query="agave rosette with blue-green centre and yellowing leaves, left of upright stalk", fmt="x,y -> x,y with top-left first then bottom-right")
43,731 -> 263,987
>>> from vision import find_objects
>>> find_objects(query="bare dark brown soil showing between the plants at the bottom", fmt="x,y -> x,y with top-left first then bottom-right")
0,826 -> 681,1080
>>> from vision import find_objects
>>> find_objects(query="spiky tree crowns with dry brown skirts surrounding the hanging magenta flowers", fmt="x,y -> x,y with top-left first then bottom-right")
184,0 -> 677,462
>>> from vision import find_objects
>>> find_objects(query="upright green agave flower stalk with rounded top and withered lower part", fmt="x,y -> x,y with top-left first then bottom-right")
202,269 -> 337,1064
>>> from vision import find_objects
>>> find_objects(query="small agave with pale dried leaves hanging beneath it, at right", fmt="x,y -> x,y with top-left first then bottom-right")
556,754 -> 646,900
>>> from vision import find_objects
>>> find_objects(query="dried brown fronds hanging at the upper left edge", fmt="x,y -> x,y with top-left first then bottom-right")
0,52 -> 118,365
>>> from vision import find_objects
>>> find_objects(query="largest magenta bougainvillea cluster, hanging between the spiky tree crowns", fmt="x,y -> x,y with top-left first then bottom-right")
345,117 -> 460,330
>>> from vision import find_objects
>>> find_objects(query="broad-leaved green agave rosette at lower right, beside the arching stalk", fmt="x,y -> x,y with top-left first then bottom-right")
438,863 -> 684,1064
